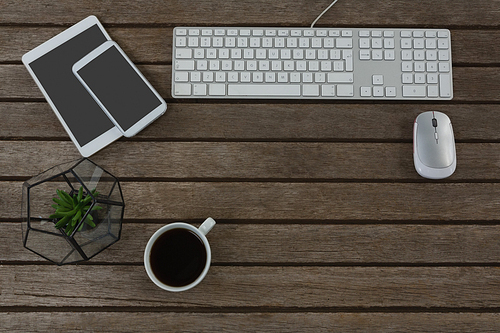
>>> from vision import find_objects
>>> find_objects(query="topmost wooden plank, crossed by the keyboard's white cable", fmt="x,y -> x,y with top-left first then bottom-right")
0,0 -> 500,27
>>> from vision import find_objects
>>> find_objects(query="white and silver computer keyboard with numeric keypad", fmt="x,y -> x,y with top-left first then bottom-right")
172,27 -> 453,100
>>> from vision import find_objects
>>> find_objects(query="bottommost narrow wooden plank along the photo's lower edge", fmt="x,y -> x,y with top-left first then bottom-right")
0,312 -> 500,333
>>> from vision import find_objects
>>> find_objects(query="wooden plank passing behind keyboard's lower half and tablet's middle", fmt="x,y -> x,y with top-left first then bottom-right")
0,65 -> 500,103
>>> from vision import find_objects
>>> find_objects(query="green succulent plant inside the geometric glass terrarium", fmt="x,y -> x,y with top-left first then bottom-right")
49,186 -> 102,236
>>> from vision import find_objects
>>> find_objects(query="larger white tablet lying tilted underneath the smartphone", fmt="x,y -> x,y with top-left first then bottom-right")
22,16 -> 122,156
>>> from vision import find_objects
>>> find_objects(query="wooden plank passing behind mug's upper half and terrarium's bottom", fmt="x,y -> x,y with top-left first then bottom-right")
0,220 -> 500,266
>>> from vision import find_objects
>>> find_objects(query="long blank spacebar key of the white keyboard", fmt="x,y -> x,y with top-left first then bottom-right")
227,84 -> 300,96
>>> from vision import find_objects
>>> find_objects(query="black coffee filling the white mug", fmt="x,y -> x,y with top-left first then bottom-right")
149,228 -> 207,287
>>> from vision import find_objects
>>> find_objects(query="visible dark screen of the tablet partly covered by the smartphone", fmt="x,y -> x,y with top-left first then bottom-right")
29,25 -> 114,146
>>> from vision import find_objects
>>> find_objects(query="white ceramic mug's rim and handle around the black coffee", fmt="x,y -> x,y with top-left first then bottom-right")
144,217 -> 215,292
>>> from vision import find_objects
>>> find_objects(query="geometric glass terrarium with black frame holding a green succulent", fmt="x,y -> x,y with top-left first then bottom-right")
22,158 -> 125,265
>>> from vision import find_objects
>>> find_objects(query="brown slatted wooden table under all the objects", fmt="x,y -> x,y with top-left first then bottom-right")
0,0 -> 500,332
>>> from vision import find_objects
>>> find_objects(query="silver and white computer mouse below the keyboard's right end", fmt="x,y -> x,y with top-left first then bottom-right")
413,111 -> 457,179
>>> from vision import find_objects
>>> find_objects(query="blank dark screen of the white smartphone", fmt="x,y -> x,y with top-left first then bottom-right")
78,46 -> 162,131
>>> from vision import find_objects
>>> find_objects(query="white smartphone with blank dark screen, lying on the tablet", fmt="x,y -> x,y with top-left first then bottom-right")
72,41 -> 167,137
